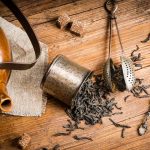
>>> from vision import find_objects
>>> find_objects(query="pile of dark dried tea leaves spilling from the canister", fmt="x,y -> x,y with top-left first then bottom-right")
66,75 -> 121,125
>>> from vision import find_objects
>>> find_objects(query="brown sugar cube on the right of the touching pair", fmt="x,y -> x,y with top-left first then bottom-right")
70,21 -> 84,36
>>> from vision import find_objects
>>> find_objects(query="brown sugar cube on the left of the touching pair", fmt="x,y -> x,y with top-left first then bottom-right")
56,13 -> 70,29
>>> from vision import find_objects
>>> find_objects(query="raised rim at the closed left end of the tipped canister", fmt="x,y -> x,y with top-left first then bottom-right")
40,54 -> 63,89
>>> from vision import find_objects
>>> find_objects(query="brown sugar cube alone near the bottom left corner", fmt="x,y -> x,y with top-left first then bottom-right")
18,133 -> 31,149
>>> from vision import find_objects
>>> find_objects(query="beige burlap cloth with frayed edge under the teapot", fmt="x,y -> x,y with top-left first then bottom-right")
0,17 -> 48,116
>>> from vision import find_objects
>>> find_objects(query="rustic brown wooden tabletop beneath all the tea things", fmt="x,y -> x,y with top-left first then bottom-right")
0,0 -> 150,150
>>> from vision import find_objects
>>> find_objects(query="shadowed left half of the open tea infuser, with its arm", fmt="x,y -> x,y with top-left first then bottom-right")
103,0 -> 118,92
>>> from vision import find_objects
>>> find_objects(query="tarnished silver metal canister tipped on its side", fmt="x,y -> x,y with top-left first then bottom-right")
41,55 -> 91,105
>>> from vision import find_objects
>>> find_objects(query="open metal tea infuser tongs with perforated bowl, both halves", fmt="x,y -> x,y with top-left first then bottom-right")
104,0 -> 135,91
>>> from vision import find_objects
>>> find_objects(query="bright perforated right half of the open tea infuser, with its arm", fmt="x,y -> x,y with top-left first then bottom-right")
105,0 -> 135,91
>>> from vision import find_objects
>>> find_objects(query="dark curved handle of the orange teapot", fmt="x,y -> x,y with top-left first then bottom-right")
0,0 -> 41,70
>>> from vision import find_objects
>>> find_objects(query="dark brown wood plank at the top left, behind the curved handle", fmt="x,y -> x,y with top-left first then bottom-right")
0,0 -> 78,21
